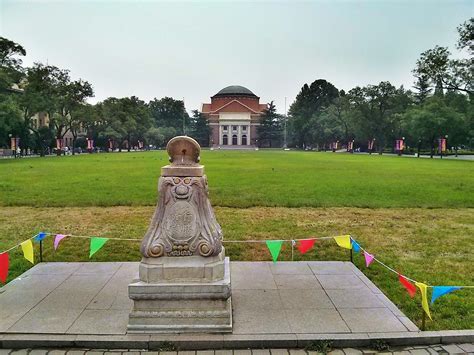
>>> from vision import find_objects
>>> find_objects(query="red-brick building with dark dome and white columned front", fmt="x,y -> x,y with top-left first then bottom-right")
201,85 -> 267,148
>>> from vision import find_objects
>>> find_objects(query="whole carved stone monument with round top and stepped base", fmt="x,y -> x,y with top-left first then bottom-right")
128,136 -> 232,333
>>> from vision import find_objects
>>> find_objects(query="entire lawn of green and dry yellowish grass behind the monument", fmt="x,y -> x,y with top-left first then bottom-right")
0,151 -> 474,330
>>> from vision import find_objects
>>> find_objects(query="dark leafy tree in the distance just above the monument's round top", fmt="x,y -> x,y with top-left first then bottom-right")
148,97 -> 190,135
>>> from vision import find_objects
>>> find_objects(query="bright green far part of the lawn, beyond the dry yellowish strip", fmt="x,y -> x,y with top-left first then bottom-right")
0,151 -> 474,208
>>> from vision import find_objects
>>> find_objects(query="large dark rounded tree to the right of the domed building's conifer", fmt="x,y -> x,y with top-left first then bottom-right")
288,79 -> 339,147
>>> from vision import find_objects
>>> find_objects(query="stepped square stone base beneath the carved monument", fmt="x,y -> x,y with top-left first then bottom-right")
128,251 -> 232,333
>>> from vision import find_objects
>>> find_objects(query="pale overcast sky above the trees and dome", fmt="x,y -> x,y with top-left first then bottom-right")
0,0 -> 474,113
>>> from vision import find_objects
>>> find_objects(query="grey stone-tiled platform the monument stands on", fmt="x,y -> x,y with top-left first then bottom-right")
0,262 -> 418,342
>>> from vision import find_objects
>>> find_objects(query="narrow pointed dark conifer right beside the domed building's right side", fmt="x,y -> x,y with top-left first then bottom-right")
257,101 -> 283,148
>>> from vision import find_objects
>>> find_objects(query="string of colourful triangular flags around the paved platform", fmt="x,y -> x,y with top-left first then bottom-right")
0,232 -> 474,319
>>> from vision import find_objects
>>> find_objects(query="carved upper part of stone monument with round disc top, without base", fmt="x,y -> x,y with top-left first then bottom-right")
141,137 -> 222,258
